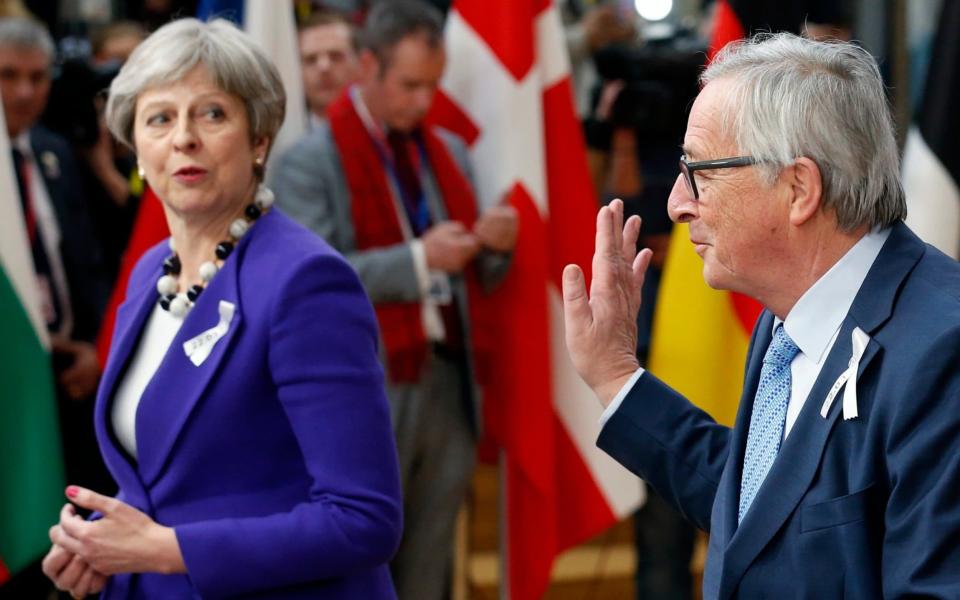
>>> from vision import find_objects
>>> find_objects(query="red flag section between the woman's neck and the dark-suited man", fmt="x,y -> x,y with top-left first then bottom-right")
97,187 -> 170,368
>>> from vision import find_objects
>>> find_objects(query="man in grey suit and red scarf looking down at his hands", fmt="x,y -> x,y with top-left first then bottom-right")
272,1 -> 517,600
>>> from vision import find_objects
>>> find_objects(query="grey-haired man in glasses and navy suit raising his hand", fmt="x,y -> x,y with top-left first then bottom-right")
563,34 -> 960,600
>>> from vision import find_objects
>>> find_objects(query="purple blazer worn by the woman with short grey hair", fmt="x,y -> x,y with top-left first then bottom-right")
95,209 -> 402,599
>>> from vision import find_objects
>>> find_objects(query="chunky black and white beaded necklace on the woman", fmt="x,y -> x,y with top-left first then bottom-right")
157,185 -> 273,318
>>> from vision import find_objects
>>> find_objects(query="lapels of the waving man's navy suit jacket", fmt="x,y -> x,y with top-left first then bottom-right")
719,223 -> 923,598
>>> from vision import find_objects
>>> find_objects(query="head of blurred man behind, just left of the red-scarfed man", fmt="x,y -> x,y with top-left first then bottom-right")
299,11 -> 360,127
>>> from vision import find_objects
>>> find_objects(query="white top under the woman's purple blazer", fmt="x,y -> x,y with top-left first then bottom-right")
110,303 -> 183,458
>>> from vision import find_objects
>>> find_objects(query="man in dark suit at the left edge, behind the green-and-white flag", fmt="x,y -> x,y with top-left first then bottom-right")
0,17 -> 113,597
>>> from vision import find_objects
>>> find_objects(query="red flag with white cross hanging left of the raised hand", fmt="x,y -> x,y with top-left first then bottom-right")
431,0 -> 643,600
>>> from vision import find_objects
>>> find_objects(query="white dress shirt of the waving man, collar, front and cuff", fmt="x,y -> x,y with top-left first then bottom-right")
600,228 -> 890,439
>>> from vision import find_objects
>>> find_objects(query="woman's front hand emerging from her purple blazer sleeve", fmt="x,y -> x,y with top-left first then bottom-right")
50,486 -> 187,575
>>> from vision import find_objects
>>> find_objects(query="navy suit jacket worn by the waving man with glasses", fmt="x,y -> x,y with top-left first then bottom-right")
598,223 -> 960,599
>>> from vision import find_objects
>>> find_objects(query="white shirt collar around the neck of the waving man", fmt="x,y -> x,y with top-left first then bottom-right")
773,227 -> 891,363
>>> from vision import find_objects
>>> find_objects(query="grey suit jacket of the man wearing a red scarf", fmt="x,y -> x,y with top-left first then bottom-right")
269,123 -> 511,428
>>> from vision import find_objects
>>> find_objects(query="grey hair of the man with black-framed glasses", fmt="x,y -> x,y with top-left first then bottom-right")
700,33 -> 907,231
